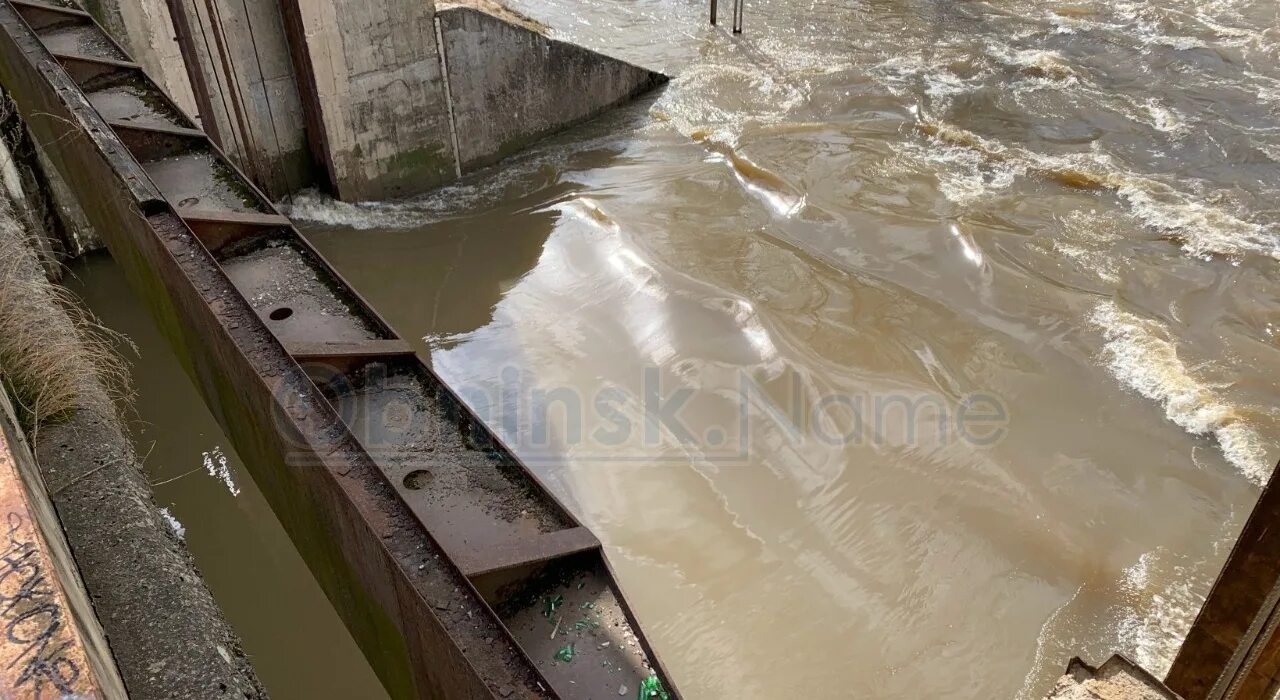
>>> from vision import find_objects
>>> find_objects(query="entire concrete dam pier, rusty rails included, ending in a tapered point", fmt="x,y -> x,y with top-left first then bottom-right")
88,0 -> 666,201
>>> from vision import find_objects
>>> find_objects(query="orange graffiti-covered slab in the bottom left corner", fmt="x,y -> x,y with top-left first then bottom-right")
0,389 -> 125,700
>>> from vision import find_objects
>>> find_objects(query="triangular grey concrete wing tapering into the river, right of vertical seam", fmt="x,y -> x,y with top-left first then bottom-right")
436,6 -> 667,173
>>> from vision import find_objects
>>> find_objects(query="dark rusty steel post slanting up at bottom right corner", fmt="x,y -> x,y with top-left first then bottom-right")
1165,460 -> 1280,700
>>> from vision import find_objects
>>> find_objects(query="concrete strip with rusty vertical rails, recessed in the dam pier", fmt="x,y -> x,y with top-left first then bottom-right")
163,0 -> 315,197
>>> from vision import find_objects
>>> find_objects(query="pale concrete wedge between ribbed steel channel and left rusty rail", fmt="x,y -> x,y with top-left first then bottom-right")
81,0 -> 198,115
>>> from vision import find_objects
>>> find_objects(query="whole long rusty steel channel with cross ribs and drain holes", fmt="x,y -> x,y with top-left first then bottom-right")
0,0 -> 676,697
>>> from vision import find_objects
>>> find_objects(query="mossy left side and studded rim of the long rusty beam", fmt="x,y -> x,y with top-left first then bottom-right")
0,1 -> 552,699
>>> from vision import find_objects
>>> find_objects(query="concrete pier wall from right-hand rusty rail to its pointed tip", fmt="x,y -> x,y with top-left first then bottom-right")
283,0 -> 666,201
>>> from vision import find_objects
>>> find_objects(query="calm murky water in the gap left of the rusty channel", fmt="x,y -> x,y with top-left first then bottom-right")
68,253 -> 387,700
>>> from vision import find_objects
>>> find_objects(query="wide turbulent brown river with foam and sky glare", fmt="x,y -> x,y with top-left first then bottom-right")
293,0 -> 1280,699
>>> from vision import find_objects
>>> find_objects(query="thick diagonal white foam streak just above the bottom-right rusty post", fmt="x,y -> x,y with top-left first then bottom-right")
1089,301 -> 1271,485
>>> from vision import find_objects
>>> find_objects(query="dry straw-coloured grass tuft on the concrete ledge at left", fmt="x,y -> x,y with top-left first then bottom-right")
0,196 -> 128,430
